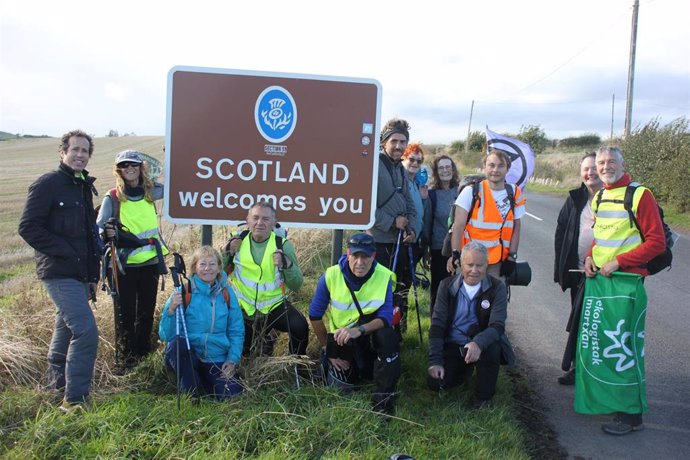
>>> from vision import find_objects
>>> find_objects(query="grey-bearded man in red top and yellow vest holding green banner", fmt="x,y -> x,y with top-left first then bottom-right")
585,146 -> 666,435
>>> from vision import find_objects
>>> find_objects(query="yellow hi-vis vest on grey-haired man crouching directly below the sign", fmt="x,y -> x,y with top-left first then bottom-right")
230,232 -> 283,316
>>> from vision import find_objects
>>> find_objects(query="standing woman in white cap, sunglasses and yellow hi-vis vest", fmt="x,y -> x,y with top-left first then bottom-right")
97,150 -> 168,373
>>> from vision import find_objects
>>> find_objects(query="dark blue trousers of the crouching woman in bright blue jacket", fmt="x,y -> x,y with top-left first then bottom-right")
165,337 -> 242,399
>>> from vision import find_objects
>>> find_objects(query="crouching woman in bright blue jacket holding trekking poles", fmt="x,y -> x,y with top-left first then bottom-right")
158,246 -> 244,399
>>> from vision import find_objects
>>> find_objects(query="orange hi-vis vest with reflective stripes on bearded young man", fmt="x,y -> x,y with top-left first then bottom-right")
462,179 -> 520,264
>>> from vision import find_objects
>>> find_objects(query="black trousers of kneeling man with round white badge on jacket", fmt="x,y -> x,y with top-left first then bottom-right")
427,341 -> 501,400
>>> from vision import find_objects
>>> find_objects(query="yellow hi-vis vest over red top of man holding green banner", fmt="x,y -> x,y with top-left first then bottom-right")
592,186 -> 647,267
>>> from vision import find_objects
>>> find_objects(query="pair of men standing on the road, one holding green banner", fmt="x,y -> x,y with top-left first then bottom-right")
554,146 -> 666,435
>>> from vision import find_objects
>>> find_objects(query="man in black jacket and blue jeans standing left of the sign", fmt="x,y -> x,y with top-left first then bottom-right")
19,130 -> 99,411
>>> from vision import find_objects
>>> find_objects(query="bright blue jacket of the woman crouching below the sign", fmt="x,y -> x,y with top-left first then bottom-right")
158,272 -> 244,364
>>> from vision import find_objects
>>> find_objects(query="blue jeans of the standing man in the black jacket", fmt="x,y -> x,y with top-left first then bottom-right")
43,278 -> 98,403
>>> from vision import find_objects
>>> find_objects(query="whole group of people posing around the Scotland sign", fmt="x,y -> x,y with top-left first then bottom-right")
19,126 -> 665,434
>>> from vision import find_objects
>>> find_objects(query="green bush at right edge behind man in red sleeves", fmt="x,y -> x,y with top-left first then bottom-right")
621,117 -> 690,212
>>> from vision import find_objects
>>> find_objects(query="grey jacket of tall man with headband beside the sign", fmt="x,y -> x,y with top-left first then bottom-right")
369,153 -> 422,243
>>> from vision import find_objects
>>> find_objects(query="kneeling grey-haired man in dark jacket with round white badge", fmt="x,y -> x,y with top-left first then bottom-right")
427,241 -> 514,409
